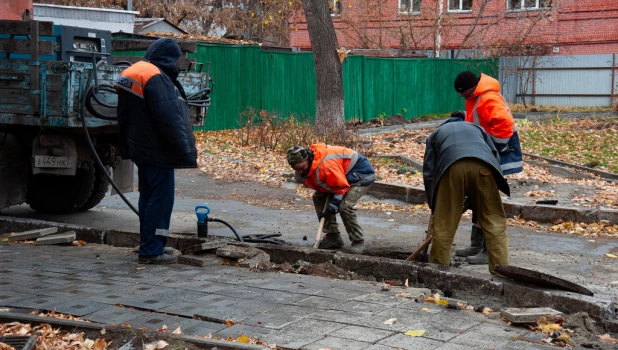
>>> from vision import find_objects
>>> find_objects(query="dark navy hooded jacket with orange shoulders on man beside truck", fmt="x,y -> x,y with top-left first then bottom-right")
116,38 -> 197,168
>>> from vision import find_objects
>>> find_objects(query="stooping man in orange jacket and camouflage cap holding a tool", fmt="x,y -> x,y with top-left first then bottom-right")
286,142 -> 376,254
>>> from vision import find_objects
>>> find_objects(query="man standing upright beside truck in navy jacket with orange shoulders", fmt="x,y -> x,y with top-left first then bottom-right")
116,38 -> 197,264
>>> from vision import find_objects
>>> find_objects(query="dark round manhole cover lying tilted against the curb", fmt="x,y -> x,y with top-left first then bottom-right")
495,265 -> 594,296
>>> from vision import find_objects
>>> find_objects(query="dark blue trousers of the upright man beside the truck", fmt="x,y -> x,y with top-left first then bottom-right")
137,166 -> 174,257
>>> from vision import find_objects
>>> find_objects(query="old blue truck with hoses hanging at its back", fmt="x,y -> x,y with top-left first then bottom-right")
0,20 -> 211,213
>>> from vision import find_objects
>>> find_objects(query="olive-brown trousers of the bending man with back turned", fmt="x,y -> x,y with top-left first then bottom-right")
429,158 -> 509,274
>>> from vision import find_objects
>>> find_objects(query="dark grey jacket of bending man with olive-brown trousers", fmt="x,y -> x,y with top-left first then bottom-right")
423,118 -> 510,210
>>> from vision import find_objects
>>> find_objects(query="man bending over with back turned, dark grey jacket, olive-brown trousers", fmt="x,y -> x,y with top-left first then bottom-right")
423,117 -> 510,274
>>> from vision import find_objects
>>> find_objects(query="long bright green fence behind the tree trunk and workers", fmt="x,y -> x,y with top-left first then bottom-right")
112,43 -> 498,130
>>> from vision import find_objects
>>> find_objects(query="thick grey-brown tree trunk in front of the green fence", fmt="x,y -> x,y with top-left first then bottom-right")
303,0 -> 345,135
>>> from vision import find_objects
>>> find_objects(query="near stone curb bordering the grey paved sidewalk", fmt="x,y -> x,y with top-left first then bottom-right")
0,216 -> 618,329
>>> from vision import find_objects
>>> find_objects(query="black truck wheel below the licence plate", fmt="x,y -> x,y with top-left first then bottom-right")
26,162 -> 94,214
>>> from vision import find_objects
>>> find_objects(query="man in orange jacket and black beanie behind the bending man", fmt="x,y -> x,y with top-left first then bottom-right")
454,71 -> 523,265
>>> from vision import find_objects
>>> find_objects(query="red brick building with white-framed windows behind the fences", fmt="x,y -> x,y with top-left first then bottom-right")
290,0 -> 618,57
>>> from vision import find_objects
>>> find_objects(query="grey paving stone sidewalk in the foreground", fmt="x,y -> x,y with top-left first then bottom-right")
0,242 -> 553,350
